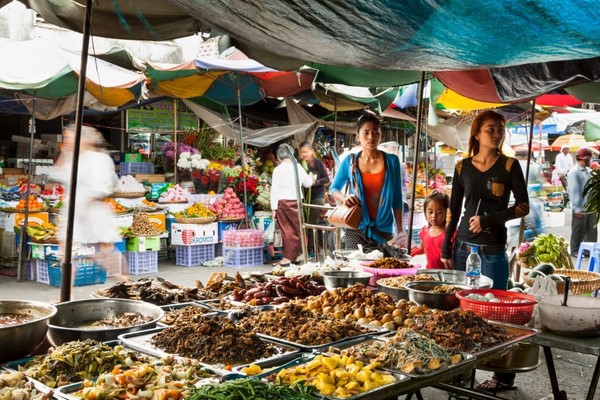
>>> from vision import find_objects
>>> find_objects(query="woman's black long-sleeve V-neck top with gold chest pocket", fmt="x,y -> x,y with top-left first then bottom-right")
442,155 -> 529,259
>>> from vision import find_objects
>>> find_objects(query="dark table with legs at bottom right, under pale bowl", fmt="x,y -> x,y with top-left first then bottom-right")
527,331 -> 600,400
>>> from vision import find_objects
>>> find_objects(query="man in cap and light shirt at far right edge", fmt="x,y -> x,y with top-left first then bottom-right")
567,147 -> 598,257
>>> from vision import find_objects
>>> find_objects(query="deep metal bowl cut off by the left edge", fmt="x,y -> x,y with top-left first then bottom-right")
0,300 -> 57,361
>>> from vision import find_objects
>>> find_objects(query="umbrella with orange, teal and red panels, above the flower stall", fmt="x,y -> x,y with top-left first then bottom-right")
146,52 -> 314,106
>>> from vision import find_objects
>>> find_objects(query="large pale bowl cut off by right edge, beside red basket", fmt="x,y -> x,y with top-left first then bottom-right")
538,295 -> 600,337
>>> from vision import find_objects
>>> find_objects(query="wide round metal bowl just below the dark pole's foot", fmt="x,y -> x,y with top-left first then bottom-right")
48,299 -> 164,346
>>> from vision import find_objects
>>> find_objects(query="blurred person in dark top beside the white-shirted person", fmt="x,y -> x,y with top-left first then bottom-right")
299,142 -> 330,252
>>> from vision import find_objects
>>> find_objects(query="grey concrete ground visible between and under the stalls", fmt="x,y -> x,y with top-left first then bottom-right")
0,211 -> 600,400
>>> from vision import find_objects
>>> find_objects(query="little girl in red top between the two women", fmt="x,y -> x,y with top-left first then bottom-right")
411,191 -> 450,269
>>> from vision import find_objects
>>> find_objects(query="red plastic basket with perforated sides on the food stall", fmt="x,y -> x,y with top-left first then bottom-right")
456,289 -> 537,325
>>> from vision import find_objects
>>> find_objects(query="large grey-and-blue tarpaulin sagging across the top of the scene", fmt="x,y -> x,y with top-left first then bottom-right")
171,0 -> 600,71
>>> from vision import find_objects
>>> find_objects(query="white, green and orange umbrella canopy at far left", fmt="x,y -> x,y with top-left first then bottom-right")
0,39 -> 145,119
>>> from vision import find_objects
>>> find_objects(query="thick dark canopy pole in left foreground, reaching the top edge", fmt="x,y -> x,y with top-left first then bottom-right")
60,0 -> 93,303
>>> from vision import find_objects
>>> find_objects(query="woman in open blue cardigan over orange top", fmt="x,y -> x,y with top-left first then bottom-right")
330,114 -> 406,249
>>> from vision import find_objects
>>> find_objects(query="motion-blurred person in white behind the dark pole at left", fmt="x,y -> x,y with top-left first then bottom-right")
55,125 -> 124,282
